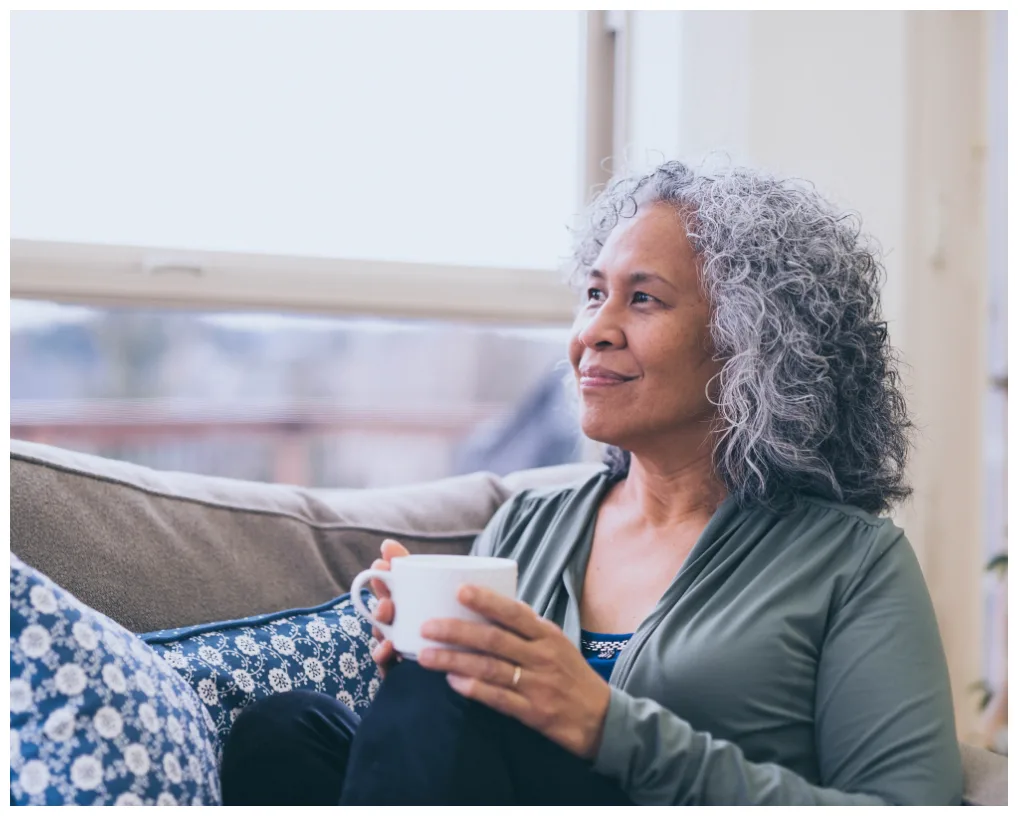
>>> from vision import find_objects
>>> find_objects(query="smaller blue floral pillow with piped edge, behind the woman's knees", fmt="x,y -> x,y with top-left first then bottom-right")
142,591 -> 382,746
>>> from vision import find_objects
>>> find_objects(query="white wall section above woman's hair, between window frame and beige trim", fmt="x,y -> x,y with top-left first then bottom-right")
628,11 -> 906,332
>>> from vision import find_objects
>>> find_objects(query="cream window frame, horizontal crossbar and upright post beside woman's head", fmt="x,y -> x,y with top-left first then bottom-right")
10,11 -> 628,326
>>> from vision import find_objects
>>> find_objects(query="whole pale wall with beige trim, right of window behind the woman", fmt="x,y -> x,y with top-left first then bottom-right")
626,11 -> 987,737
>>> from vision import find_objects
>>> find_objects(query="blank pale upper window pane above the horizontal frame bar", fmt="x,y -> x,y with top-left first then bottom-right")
11,11 -> 581,269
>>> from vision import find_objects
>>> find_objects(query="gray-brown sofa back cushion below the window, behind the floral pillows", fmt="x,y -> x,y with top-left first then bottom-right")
10,441 -> 529,632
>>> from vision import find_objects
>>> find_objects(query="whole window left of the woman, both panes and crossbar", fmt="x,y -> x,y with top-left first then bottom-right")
11,12 -> 588,486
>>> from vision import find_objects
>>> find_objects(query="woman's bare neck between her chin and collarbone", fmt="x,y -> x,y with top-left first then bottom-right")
616,449 -> 727,527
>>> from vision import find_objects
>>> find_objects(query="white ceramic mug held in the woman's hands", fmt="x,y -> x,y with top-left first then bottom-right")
350,556 -> 516,659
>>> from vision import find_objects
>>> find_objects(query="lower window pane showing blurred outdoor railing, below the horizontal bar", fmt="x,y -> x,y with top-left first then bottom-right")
10,300 -> 581,487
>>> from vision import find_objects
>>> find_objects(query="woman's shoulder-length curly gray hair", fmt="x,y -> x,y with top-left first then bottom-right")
569,162 -> 912,513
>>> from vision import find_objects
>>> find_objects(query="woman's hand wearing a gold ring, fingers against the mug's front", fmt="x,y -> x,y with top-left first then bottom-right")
417,586 -> 611,759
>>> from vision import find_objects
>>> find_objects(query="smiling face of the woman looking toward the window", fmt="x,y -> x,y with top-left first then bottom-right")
569,202 -> 721,452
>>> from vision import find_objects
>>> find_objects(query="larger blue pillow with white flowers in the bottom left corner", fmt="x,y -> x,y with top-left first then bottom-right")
10,555 -> 220,805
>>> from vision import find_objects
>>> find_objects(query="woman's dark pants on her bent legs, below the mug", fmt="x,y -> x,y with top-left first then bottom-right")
222,660 -> 630,805
